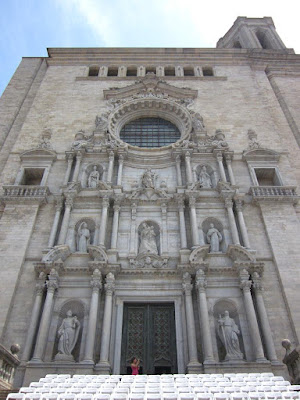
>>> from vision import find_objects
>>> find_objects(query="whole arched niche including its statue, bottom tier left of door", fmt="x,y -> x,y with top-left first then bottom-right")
53,300 -> 84,362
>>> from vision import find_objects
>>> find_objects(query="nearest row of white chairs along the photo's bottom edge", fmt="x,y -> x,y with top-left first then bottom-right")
7,391 -> 300,400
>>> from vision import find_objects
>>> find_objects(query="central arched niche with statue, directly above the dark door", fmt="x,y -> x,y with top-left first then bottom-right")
138,220 -> 161,255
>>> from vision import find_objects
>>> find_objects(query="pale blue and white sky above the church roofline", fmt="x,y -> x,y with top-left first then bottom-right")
0,0 -> 300,93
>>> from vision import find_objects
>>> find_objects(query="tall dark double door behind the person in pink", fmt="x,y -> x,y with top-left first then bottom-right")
121,303 -> 177,374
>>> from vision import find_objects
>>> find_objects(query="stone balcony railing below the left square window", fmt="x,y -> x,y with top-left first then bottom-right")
3,185 -> 49,202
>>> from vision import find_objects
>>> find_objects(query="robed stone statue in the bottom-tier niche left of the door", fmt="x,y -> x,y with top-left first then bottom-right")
55,310 -> 80,360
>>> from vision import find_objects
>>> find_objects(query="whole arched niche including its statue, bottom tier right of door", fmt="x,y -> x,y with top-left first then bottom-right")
213,299 -> 245,361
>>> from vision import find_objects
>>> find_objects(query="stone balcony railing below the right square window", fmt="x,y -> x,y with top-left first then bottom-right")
250,186 -> 298,202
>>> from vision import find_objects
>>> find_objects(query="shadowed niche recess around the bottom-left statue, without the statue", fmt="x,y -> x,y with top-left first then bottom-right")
53,299 -> 85,362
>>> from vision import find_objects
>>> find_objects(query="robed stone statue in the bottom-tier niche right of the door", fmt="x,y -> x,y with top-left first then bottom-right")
218,311 -> 243,361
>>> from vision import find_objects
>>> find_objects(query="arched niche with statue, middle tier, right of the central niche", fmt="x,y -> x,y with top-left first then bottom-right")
202,217 -> 226,253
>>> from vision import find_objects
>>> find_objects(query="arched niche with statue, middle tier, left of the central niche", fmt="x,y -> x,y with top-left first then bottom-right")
75,218 -> 96,253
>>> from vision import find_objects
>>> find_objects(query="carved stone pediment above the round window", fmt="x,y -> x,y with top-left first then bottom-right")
103,75 -> 198,100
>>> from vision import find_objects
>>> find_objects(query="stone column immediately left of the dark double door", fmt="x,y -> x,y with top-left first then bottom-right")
97,272 -> 115,374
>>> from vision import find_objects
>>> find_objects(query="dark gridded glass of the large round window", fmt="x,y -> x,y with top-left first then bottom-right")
120,117 -> 180,147
